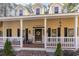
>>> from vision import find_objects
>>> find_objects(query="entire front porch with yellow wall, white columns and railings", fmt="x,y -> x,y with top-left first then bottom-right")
0,15 -> 79,50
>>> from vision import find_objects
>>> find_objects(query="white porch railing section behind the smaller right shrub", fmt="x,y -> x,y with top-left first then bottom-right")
46,37 -> 76,49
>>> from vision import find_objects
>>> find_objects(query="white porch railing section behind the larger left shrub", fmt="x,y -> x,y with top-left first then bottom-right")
0,37 -> 21,47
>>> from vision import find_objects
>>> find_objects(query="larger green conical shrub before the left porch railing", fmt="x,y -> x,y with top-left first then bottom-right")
4,39 -> 14,56
